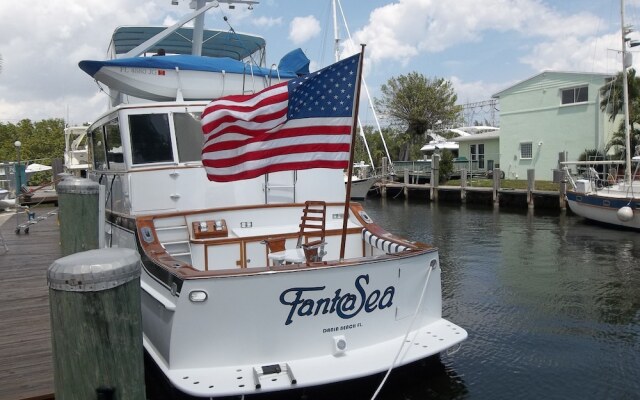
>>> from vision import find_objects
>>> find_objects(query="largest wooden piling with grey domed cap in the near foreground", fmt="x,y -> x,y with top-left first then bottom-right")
47,248 -> 145,400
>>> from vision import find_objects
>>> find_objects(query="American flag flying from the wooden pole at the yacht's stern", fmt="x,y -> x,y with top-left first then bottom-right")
202,54 -> 360,182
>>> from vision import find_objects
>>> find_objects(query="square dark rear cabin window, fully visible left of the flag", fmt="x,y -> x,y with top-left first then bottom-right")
129,114 -> 173,164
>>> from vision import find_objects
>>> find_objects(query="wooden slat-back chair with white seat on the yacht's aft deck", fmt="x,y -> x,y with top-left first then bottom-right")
263,201 -> 327,265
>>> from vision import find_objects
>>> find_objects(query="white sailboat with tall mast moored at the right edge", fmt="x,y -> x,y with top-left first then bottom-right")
564,0 -> 640,230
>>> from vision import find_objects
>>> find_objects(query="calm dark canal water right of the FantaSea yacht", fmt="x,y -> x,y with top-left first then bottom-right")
155,198 -> 640,400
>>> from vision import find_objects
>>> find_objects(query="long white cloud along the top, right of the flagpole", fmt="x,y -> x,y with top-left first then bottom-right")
354,0 -> 602,65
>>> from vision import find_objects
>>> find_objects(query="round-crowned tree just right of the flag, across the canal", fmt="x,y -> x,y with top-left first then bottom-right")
375,72 -> 462,161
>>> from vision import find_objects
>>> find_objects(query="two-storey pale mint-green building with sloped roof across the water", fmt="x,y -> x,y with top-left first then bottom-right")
490,71 -> 617,180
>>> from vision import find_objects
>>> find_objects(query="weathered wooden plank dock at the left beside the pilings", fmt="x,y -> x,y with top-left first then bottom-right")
0,207 -> 60,400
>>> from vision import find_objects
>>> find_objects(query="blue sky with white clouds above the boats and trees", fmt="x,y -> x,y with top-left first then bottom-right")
0,0 -> 640,125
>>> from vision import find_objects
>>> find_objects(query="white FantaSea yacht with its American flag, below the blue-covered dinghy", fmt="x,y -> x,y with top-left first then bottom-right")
81,0 -> 467,398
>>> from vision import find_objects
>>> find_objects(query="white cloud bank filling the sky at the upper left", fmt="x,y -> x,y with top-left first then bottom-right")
0,0 -> 251,123
